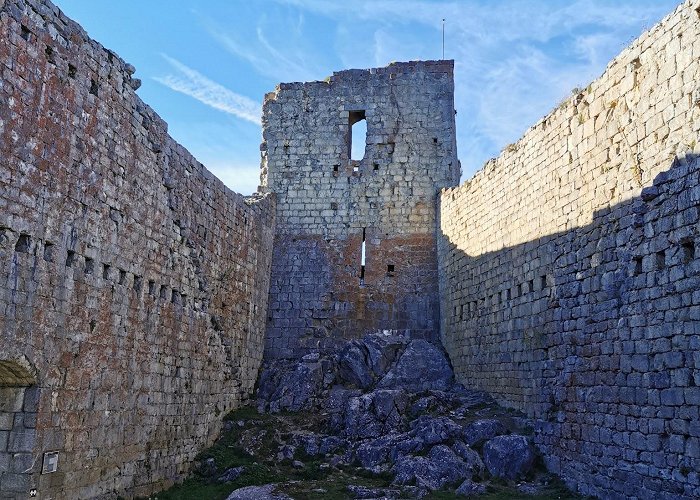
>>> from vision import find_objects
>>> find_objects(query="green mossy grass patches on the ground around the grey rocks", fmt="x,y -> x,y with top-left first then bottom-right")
145,404 -> 581,500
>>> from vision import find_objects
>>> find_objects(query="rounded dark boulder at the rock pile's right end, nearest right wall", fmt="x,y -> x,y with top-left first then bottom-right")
483,434 -> 535,479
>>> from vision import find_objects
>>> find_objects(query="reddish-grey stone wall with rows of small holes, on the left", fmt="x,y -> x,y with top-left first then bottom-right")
0,0 -> 274,498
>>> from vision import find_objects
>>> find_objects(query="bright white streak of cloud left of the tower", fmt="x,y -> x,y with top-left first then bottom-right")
154,54 -> 261,125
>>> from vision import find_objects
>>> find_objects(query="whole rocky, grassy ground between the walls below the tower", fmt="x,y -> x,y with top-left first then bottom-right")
152,332 -> 579,500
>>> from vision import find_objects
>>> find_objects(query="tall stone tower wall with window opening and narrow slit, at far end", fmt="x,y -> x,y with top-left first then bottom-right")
261,61 -> 459,358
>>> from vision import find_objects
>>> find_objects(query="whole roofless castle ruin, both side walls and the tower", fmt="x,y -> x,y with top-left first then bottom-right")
0,0 -> 700,500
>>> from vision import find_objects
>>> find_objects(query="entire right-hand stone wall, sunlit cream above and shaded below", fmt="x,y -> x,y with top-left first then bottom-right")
439,0 -> 700,499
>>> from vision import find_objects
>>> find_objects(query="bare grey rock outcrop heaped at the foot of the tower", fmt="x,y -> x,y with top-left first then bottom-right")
257,332 -> 535,498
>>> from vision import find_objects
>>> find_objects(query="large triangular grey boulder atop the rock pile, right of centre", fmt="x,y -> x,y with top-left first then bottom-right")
377,339 -> 454,393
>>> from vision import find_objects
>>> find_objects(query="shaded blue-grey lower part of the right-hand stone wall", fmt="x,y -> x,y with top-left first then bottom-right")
439,154 -> 700,499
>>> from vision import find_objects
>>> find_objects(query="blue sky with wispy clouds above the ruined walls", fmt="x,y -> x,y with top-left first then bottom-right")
55,0 -> 679,194
